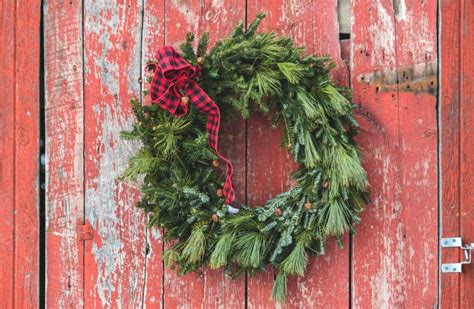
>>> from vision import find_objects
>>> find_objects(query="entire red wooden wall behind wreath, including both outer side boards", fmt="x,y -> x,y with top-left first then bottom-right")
0,0 -> 440,308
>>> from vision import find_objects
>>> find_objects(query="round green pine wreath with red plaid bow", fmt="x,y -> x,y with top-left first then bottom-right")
122,13 -> 368,302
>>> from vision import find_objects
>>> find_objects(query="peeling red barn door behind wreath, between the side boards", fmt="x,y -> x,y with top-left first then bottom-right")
44,0 -> 438,308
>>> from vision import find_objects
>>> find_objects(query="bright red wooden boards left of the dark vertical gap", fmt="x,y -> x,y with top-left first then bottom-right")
0,0 -> 41,308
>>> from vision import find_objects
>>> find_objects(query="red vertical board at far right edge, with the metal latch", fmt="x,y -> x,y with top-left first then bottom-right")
439,0 -> 474,308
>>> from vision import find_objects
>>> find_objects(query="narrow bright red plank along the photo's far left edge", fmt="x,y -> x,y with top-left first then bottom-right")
0,1 -> 15,307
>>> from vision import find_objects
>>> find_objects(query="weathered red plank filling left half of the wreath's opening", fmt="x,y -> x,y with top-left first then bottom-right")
164,0 -> 245,308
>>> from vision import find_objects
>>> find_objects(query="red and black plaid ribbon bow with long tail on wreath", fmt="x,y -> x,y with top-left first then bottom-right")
146,46 -> 235,205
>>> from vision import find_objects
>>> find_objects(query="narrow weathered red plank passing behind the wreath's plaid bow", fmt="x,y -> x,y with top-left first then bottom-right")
141,0 -> 165,308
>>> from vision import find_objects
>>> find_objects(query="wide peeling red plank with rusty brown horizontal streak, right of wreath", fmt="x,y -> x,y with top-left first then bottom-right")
351,0 -> 437,308
